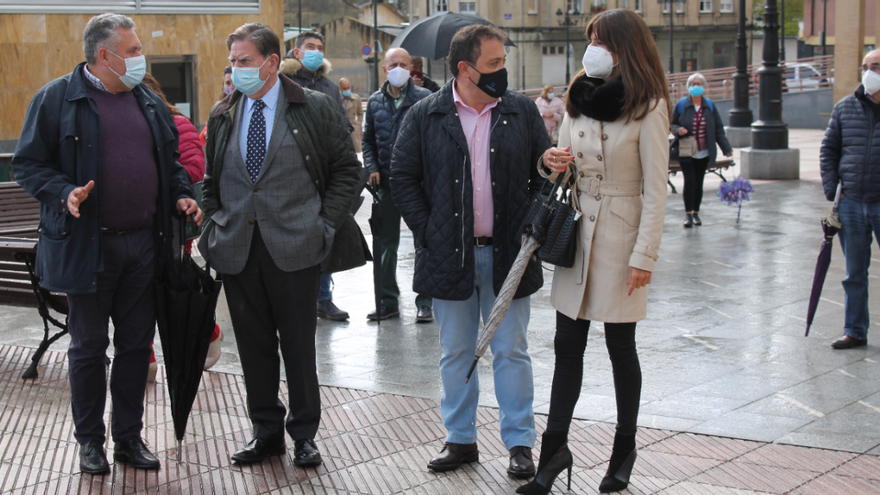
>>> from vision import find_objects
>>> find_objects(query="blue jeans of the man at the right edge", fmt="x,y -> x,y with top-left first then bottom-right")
837,196 -> 880,339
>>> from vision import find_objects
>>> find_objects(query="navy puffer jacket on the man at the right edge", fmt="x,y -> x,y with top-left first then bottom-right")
819,86 -> 880,203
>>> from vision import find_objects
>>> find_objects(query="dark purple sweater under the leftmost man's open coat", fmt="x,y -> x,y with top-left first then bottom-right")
88,86 -> 159,229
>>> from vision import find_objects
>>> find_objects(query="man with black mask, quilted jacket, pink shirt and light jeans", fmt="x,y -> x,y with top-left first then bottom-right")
391,25 -> 551,478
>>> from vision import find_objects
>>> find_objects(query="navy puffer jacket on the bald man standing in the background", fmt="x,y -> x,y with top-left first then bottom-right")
362,78 -> 431,184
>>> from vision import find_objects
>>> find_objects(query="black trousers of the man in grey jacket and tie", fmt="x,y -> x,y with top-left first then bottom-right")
223,226 -> 321,440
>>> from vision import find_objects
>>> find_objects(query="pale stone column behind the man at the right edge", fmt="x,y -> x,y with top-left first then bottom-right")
834,0 -> 865,103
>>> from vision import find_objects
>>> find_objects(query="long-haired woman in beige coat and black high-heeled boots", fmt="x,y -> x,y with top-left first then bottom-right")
517,9 -> 669,493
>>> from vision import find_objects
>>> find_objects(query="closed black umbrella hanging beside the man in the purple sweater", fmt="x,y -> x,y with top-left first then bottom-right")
155,217 -> 221,459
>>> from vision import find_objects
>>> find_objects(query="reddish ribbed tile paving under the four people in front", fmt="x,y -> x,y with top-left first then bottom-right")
0,345 -> 880,495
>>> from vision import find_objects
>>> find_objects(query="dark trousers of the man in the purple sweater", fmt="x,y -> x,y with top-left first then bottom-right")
67,229 -> 156,444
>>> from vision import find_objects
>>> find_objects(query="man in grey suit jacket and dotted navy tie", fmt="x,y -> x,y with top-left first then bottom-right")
199,23 -> 360,466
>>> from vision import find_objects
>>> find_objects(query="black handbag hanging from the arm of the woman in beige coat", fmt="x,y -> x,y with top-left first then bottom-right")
538,169 -> 581,268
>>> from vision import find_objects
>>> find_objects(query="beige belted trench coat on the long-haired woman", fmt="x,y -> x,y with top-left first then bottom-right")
538,102 -> 669,323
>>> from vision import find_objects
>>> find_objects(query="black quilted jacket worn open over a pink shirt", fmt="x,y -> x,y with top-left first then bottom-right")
391,81 -> 551,300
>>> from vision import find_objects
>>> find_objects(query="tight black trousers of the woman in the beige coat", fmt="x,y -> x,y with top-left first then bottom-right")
547,312 -> 642,435
